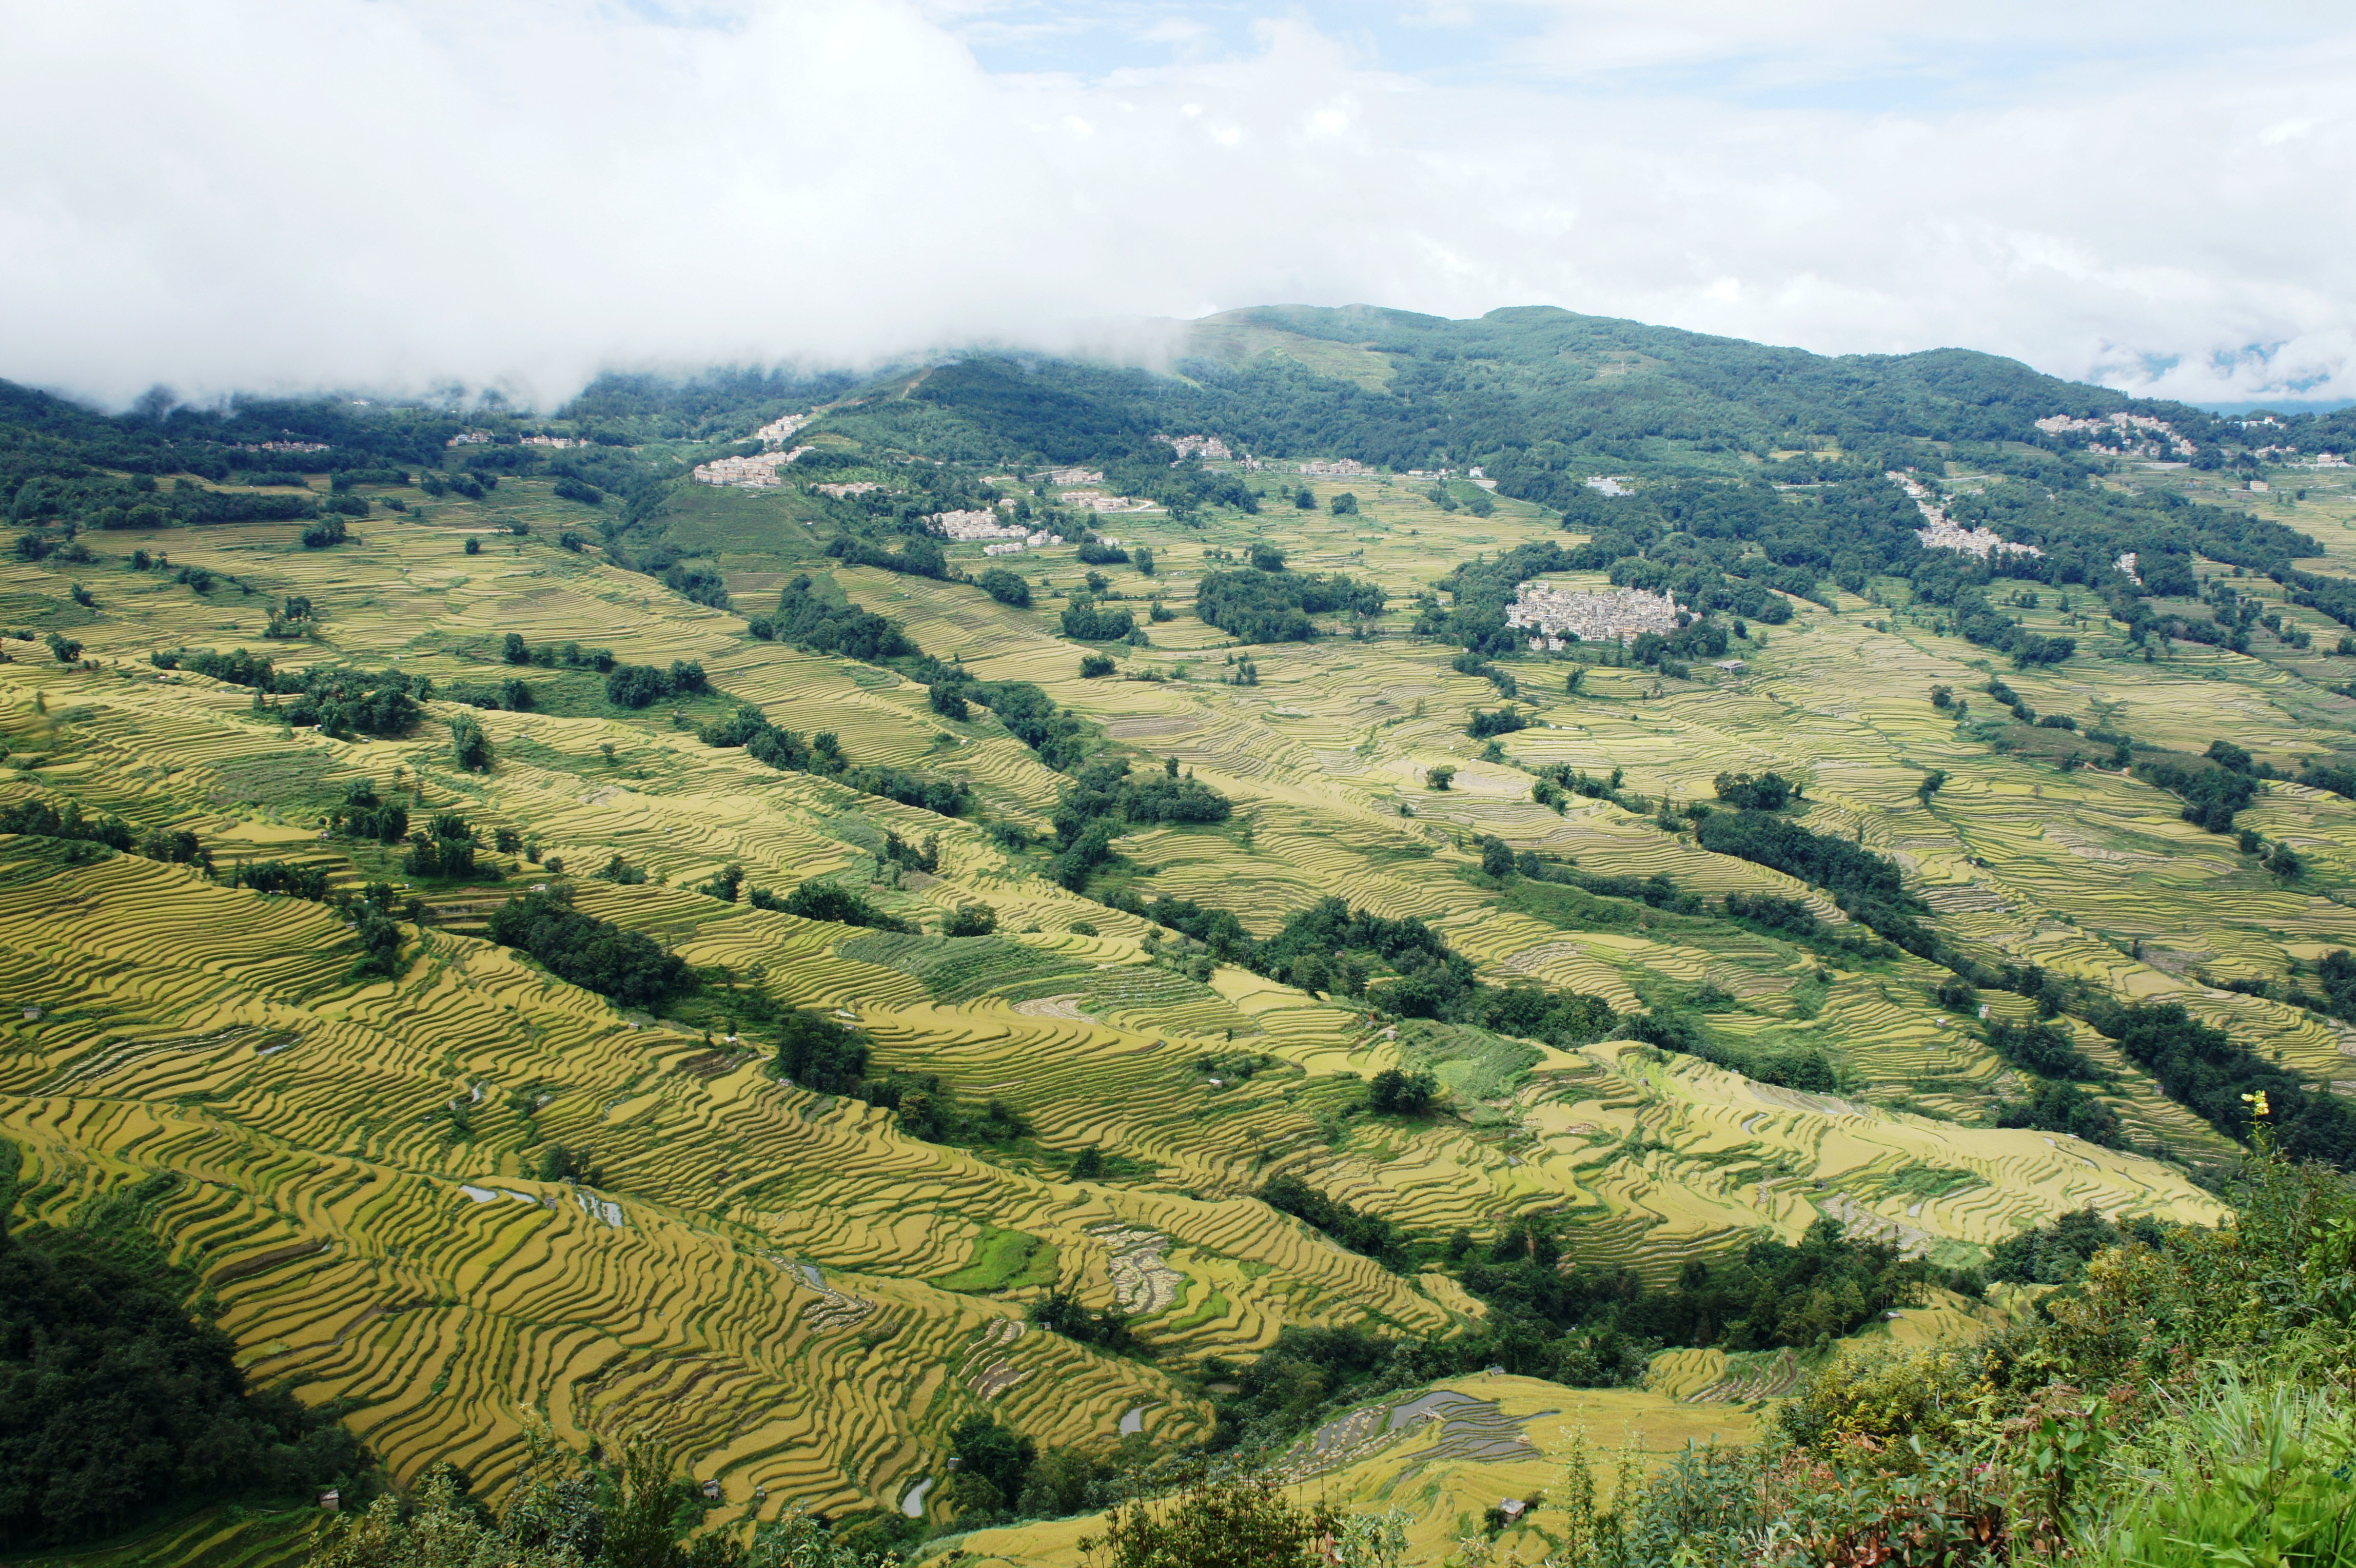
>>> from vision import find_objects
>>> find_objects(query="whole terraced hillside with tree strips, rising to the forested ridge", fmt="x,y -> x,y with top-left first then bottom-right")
0,311 -> 2356,1549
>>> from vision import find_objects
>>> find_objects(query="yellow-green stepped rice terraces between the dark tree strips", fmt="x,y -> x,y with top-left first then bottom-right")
0,329 -> 2356,1561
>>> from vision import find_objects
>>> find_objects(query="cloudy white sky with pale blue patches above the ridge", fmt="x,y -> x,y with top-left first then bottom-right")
0,0 -> 2356,400
